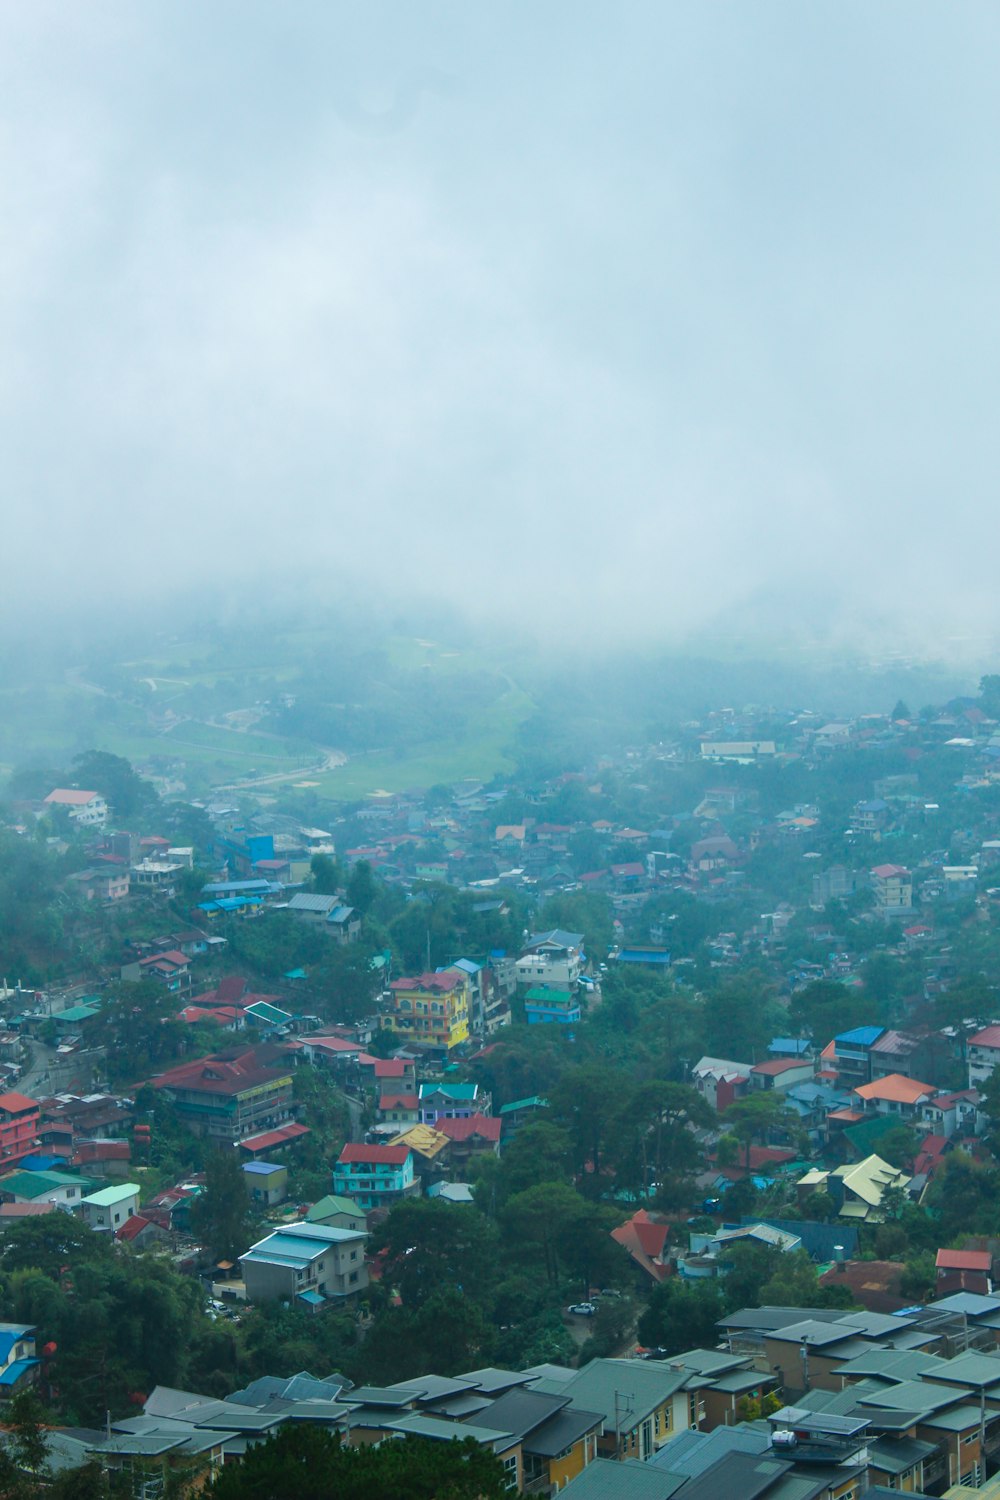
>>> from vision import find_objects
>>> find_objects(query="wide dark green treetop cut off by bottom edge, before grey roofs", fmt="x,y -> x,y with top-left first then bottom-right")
205,1422 -> 508,1500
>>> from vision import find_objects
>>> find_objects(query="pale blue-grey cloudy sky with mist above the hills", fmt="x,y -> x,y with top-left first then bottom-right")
0,0 -> 1000,653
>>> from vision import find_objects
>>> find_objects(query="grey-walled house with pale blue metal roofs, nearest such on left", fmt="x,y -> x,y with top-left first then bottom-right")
240,1223 -> 367,1311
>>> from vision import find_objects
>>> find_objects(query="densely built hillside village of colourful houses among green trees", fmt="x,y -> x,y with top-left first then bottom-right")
7,678 -> 1000,1500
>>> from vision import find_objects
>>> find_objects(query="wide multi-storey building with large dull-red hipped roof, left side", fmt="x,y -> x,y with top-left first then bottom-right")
150,1047 -> 294,1145
